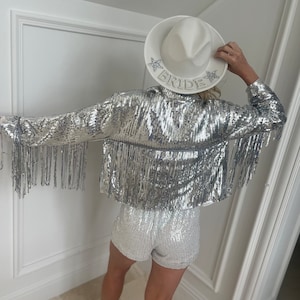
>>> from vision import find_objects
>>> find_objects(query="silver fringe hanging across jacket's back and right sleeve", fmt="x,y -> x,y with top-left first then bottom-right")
100,129 -> 282,210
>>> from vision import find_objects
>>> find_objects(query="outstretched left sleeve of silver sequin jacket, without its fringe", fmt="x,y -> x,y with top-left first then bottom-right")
0,98 -> 119,146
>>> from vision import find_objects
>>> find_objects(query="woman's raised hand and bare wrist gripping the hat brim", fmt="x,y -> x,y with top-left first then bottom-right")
215,42 -> 258,85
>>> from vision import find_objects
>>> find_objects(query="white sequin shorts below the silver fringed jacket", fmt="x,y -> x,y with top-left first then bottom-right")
112,205 -> 200,269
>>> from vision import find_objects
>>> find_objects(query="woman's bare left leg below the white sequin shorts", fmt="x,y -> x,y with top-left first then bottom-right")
101,242 -> 135,300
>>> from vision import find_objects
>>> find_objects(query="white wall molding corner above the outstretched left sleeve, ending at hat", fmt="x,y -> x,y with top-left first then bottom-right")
11,10 -> 146,113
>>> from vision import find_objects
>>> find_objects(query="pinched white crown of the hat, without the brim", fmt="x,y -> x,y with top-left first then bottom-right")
161,17 -> 212,78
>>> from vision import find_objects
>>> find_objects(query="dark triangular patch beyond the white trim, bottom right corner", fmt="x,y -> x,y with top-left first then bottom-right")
277,239 -> 300,300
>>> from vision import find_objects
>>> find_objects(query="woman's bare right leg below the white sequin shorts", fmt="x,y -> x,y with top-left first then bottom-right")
145,261 -> 186,300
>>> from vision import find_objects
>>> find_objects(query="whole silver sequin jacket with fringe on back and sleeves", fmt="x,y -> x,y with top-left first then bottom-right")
0,80 -> 286,210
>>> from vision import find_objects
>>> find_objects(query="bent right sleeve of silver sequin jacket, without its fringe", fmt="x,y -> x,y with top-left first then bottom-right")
221,79 -> 286,139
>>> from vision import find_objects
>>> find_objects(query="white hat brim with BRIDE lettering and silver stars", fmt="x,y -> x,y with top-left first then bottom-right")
144,16 -> 228,94
